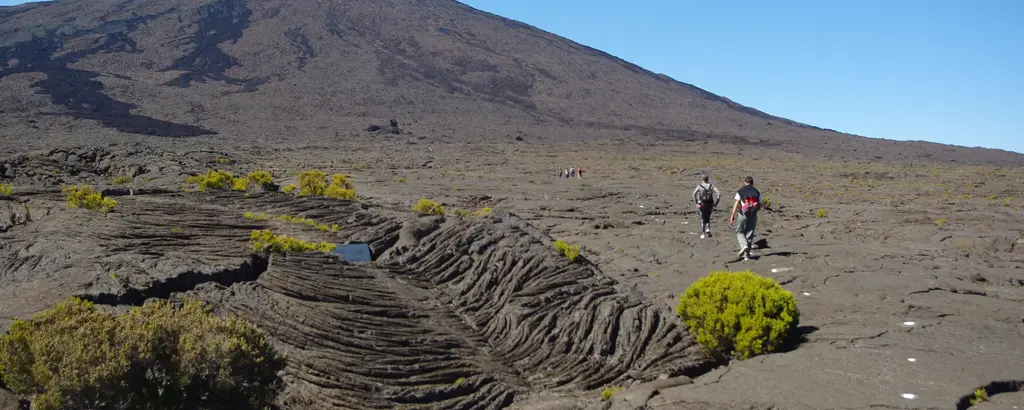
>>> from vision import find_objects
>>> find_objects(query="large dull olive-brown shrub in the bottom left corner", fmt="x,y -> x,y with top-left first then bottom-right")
0,298 -> 285,410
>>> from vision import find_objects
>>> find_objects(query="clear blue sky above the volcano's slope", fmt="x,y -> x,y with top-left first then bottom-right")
0,0 -> 1024,153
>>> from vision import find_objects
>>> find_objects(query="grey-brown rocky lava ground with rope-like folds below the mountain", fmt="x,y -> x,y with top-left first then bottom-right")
0,136 -> 1024,409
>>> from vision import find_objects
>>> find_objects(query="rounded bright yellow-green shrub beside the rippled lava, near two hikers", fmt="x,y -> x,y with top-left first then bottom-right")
676,272 -> 800,359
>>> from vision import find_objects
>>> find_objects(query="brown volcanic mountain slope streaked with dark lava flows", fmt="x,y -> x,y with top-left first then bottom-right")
0,0 -> 1024,164
